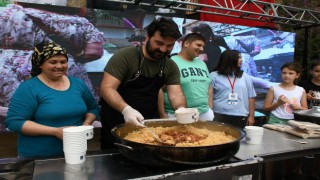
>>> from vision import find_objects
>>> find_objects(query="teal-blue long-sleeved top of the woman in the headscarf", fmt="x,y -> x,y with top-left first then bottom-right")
5,77 -> 99,157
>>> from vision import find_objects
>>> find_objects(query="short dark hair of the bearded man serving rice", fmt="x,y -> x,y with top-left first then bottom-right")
147,18 -> 182,40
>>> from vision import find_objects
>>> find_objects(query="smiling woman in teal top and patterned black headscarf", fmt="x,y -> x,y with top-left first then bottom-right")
5,43 -> 99,157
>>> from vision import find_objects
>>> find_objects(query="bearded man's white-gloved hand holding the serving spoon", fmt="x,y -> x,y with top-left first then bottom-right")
122,106 -> 144,127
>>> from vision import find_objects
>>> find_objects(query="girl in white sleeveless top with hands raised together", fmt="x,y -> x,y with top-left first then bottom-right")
264,62 -> 307,124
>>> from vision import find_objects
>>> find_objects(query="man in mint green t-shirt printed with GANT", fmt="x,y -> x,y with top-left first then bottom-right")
159,33 -> 214,121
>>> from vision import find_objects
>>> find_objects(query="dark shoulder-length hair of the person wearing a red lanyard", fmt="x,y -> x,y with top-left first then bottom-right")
214,50 -> 243,77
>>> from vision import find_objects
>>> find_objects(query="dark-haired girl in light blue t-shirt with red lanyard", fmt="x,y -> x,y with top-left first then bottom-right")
210,50 -> 256,128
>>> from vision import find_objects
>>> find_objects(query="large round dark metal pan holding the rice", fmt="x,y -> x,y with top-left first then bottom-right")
111,121 -> 245,166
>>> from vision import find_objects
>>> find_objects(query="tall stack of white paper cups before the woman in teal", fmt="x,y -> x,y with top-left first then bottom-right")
63,126 -> 87,164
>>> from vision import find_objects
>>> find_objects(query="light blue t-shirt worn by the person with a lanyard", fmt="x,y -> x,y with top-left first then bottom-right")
210,71 -> 256,116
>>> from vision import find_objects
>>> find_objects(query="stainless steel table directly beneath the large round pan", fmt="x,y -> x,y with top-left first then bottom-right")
33,153 -> 262,180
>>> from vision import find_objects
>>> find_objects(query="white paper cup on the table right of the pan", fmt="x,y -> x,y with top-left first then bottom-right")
244,126 -> 263,144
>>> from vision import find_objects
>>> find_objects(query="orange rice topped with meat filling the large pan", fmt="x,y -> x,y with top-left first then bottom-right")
124,125 -> 236,147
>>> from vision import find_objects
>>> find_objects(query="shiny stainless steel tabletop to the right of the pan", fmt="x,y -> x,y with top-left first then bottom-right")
236,128 -> 320,162
